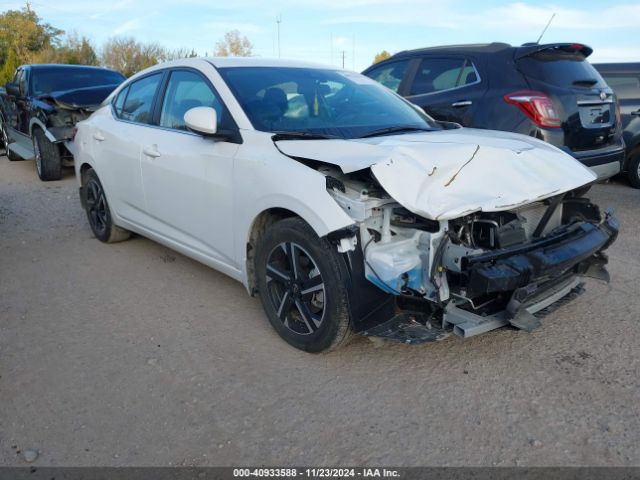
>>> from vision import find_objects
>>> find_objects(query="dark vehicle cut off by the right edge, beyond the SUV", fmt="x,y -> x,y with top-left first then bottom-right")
593,63 -> 640,188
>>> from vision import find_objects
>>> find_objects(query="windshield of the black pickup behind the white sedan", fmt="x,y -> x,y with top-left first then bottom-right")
31,67 -> 124,96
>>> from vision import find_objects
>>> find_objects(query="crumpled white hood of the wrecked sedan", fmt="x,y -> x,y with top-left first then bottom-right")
278,128 -> 597,220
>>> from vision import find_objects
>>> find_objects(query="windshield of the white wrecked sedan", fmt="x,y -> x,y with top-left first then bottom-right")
219,67 -> 439,138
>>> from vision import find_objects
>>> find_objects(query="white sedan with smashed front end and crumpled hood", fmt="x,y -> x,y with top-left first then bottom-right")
68,58 -> 618,352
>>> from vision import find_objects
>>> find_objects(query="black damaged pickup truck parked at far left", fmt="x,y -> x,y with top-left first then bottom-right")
0,65 -> 124,181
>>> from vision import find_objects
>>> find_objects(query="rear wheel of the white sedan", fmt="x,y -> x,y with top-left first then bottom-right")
82,169 -> 131,243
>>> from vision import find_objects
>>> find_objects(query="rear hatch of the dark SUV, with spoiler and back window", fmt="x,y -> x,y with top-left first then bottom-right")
515,43 -> 618,152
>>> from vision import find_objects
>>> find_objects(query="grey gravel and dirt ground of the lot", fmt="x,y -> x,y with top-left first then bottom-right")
0,157 -> 640,466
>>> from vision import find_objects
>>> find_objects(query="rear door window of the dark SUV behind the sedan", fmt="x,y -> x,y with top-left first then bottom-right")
409,58 -> 479,95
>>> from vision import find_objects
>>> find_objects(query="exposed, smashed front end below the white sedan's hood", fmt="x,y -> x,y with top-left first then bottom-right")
318,166 -> 619,343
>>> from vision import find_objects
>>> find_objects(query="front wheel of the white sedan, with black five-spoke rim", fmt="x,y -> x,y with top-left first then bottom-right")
255,218 -> 351,353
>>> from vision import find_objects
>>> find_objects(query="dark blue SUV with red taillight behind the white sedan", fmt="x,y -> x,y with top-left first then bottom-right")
363,43 -> 624,179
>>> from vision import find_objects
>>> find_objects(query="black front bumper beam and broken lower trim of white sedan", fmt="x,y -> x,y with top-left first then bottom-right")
362,212 -> 619,344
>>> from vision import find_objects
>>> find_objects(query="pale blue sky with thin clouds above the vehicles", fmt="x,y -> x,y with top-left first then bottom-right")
5,0 -> 640,70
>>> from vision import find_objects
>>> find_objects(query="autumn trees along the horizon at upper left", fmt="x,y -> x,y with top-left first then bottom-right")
0,3 -> 253,85
